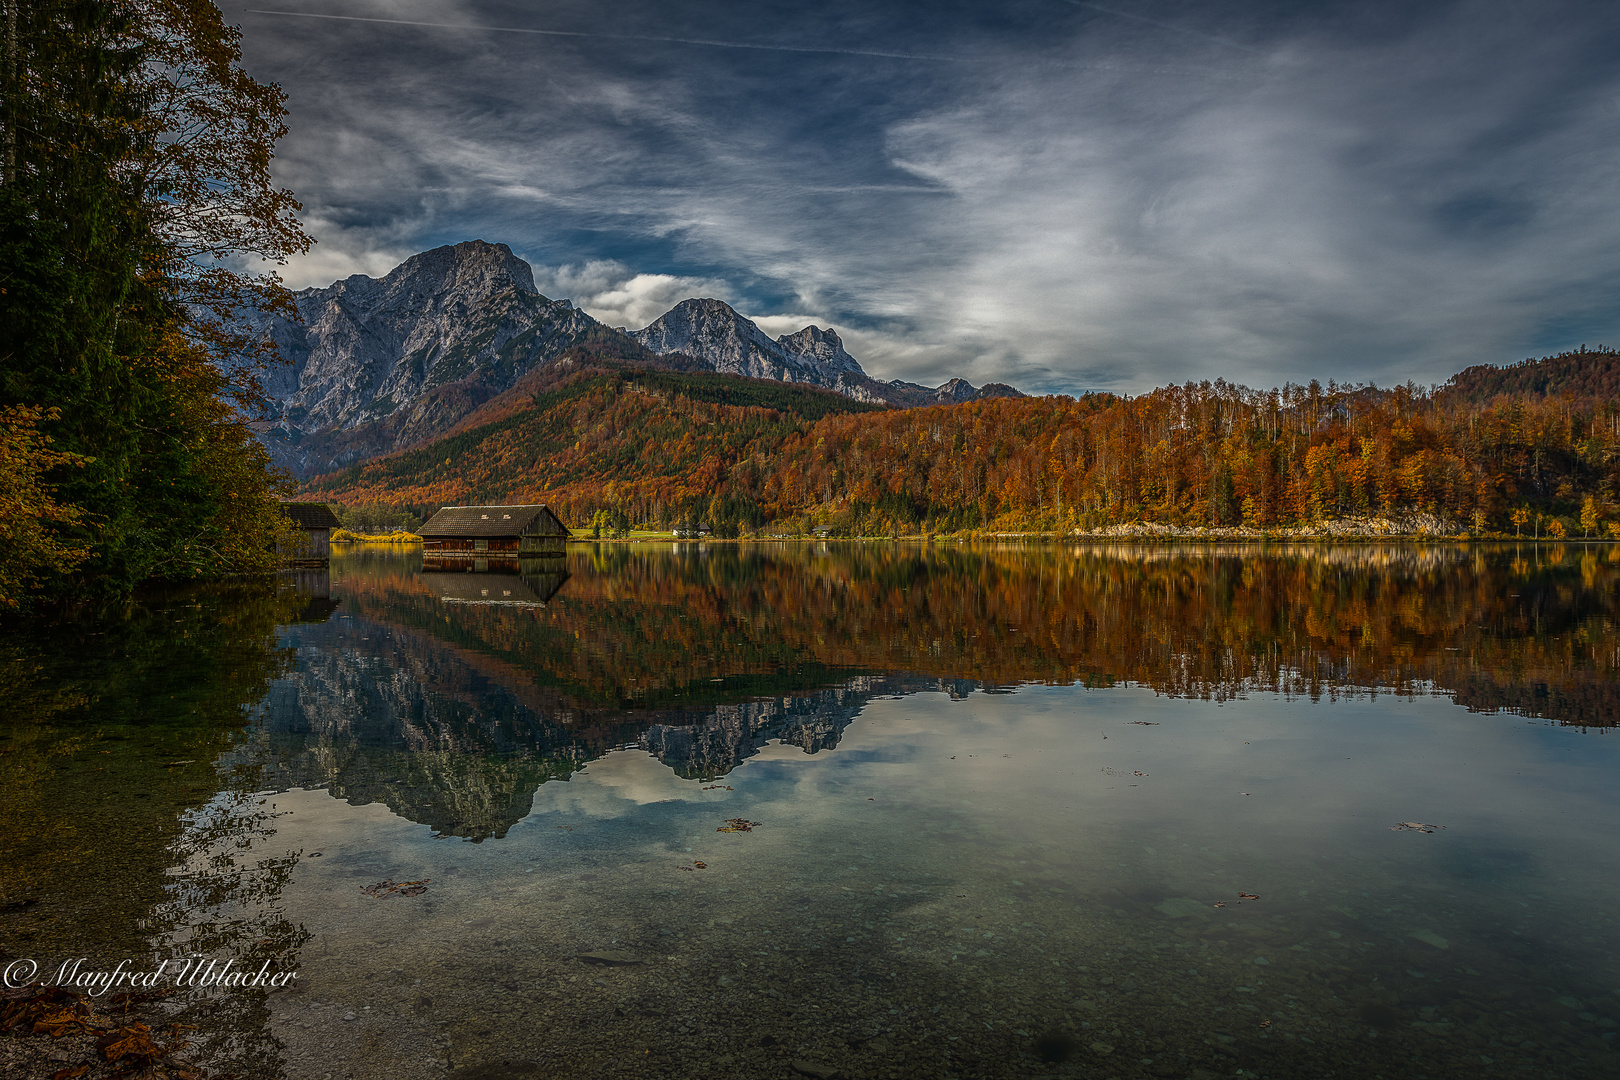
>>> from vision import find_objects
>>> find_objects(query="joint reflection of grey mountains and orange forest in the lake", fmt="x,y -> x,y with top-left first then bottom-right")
233,544 -> 1620,840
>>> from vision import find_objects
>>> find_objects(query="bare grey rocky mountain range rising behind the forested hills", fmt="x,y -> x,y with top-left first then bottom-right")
254,240 -> 1017,476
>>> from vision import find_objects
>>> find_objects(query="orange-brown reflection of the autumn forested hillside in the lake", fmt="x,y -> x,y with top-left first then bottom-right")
328,544 -> 1620,725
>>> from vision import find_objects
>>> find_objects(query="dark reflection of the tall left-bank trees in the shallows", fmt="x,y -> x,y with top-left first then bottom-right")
0,582 -> 319,1077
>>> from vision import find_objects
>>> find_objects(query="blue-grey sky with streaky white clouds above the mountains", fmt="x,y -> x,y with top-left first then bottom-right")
220,0 -> 1620,393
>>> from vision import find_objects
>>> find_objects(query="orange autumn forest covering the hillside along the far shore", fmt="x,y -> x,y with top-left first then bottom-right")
308,356 -> 1620,536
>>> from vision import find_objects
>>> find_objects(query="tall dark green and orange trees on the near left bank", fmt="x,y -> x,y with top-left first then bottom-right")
0,0 -> 309,607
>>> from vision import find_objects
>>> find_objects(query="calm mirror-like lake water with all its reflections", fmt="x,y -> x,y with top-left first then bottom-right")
0,544 -> 1620,1080
